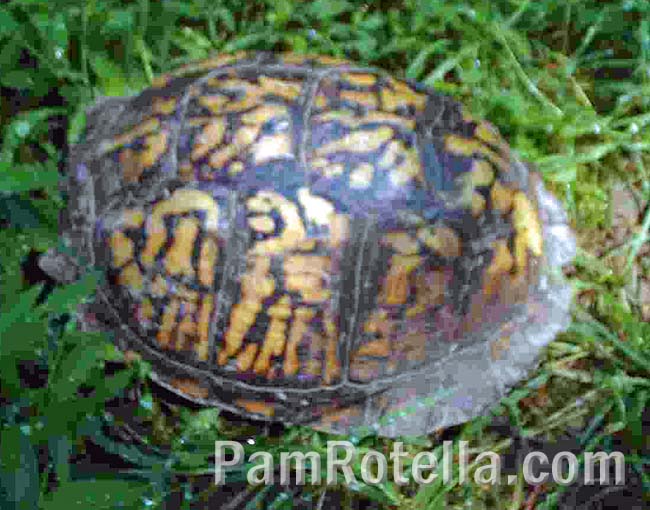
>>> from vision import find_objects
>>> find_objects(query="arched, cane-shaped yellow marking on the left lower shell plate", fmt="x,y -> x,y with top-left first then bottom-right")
141,188 -> 219,267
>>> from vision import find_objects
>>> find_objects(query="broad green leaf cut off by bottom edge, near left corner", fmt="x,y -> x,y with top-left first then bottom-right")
41,480 -> 151,510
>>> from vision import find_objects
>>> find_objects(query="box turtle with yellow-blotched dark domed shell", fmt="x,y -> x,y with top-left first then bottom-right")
40,52 -> 575,437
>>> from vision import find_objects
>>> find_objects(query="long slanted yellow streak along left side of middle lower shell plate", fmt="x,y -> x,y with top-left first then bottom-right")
218,257 -> 275,365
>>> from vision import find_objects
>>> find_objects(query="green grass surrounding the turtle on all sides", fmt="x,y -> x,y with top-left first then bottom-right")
0,0 -> 650,509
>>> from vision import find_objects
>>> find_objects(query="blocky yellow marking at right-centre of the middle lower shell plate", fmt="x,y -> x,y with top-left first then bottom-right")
284,255 -> 331,303
